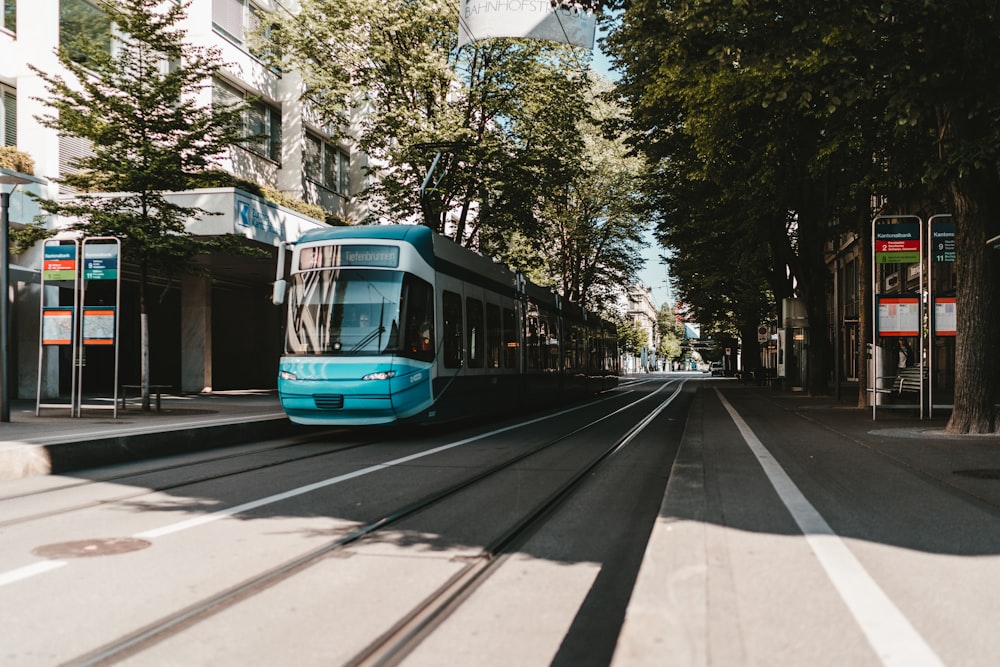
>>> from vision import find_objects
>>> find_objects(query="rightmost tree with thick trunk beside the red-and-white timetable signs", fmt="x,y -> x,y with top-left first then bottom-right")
870,0 -> 1000,433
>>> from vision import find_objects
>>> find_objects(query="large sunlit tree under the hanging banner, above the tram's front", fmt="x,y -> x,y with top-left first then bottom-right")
277,0 -> 564,246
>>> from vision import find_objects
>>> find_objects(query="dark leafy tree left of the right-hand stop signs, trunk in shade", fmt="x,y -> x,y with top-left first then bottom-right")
612,0 -> 872,393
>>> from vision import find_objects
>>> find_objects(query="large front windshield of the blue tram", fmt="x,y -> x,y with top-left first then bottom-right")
286,269 -> 434,360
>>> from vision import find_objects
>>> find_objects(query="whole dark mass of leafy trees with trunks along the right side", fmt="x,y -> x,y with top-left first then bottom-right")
608,0 -> 1000,432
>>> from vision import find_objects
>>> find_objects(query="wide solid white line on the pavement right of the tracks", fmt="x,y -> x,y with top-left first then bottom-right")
715,389 -> 944,667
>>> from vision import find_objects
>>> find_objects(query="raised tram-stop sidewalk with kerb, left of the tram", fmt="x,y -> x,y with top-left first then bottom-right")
0,390 -> 300,480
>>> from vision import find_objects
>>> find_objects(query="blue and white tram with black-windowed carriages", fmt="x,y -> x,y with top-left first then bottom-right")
274,225 -> 618,425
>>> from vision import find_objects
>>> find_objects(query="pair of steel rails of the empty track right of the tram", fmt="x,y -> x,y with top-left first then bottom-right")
65,382 -> 684,667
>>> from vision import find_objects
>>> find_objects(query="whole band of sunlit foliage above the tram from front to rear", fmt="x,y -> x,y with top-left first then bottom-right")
270,0 -> 637,314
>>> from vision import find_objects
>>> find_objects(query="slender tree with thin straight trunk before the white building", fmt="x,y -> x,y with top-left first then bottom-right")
32,0 -> 249,410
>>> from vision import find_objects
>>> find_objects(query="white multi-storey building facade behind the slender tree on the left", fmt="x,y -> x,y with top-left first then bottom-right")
0,0 -> 368,398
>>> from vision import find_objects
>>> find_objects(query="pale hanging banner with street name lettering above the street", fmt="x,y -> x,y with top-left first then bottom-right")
458,0 -> 597,49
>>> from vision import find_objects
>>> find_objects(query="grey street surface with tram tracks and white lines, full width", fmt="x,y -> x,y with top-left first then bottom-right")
0,376 -> 1000,666
